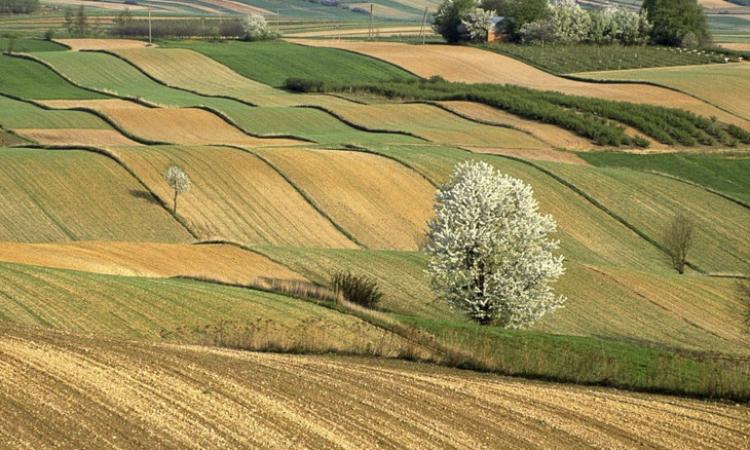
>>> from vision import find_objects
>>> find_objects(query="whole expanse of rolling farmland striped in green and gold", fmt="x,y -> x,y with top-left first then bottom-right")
0,34 -> 750,449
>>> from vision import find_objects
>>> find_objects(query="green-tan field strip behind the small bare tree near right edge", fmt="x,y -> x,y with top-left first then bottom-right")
541,163 -> 750,273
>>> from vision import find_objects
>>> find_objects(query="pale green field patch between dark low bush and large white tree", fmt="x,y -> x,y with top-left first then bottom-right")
254,247 -> 452,320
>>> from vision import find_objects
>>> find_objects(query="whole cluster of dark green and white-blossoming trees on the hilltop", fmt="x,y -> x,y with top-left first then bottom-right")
433,0 -> 710,47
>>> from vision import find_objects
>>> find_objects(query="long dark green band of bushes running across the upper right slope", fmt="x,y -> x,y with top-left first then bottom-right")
285,77 -> 750,147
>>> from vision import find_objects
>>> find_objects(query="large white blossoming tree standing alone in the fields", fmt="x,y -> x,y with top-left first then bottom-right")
425,161 -> 565,328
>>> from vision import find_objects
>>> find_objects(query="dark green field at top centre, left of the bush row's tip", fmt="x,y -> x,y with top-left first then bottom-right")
160,41 -> 416,86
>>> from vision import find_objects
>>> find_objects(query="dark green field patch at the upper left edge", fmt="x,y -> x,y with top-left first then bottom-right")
0,55 -> 107,100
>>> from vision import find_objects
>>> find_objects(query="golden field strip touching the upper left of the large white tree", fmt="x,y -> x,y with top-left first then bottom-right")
256,149 -> 435,250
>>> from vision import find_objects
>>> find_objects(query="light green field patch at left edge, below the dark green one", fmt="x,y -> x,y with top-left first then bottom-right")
0,95 -> 111,130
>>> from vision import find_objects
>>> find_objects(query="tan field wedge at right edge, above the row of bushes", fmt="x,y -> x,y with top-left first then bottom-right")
577,63 -> 750,120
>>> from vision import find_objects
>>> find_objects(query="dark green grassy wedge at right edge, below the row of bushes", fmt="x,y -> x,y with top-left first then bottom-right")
580,152 -> 750,203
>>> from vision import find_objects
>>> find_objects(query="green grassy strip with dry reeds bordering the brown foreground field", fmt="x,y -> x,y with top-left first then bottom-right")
403,317 -> 750,401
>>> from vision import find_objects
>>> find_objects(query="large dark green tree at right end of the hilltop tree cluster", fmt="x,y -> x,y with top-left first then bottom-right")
642,0 -> 711,47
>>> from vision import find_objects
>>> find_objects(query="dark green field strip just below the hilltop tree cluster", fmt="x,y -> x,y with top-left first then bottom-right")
481,43 -> 740,74
